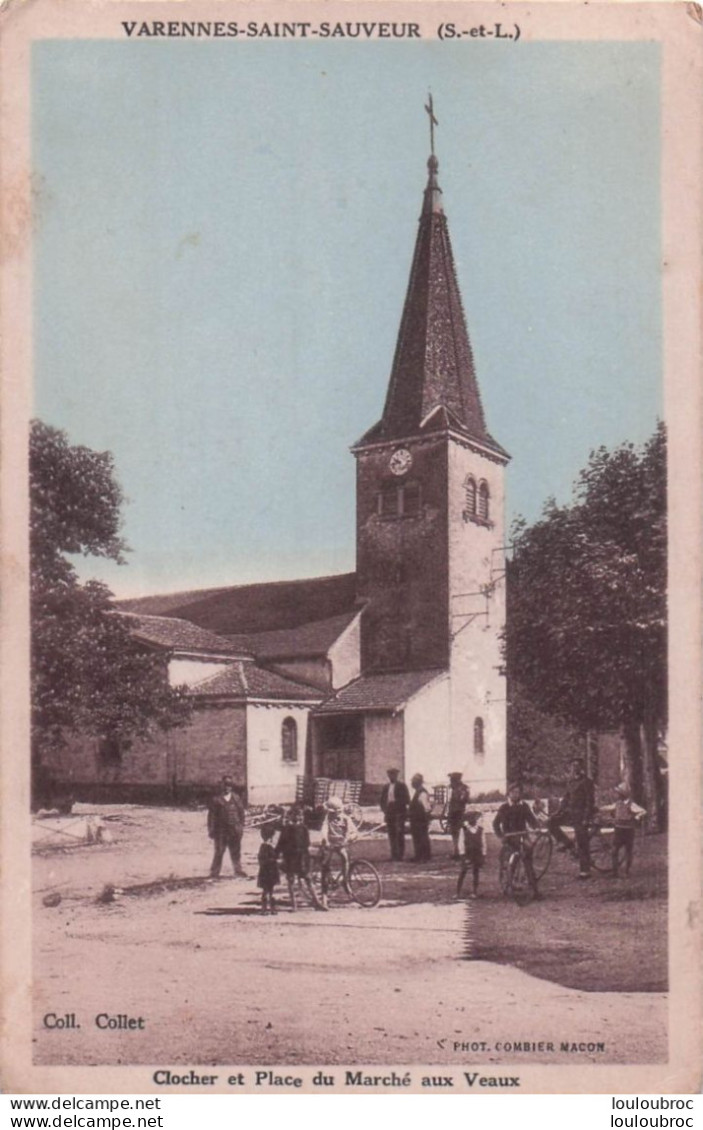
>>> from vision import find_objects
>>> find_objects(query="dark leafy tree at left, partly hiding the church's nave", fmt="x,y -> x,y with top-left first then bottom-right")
29,420 -> 190,786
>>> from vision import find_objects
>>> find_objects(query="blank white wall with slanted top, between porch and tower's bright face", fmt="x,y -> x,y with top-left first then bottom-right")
405,676 -> 454,786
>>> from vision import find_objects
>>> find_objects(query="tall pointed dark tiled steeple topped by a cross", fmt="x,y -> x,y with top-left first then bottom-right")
362,121 -> 504,454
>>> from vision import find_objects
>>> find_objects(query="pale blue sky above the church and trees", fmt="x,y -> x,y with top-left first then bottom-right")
33,41 -> 661,594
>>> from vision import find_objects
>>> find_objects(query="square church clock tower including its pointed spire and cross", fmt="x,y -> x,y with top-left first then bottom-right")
353,121 -> 510,791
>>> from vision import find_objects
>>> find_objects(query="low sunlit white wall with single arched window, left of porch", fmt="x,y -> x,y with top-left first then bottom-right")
246,703 -> 310,805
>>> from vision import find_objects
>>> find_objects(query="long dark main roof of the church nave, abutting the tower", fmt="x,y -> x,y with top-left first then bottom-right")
115,573 -> 356,635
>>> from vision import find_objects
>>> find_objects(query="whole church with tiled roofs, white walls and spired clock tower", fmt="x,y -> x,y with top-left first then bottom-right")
56,129 -> 510,803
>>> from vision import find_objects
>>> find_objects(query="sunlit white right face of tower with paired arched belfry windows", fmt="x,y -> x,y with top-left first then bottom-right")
449,433 -> 506,792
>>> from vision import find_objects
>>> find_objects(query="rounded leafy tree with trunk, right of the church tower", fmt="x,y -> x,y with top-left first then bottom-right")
505,425 -> 667,814
